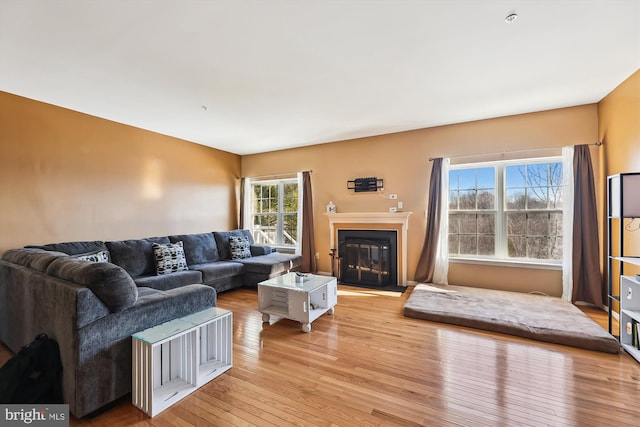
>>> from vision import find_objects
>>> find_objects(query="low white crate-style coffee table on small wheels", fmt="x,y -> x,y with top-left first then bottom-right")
258,273 -> 338,332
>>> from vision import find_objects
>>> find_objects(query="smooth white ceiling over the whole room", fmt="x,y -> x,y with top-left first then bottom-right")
0,0 -> 640,154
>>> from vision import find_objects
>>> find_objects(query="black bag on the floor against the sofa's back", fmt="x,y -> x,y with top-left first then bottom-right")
0,334 -> 64,403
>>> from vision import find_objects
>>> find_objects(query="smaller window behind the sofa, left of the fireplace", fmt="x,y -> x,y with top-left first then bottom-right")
250,178 -> 300,248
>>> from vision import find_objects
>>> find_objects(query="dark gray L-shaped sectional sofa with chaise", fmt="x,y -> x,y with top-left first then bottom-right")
0,230 -> 301,417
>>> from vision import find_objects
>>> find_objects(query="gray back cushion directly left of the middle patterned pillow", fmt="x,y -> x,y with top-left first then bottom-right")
106,237 -> 170,278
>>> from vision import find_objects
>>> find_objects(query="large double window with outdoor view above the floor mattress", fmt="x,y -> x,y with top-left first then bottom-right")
449,158 -> 562,263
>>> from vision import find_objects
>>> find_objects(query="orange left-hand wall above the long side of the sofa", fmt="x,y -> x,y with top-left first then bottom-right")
0,92 -> 240,253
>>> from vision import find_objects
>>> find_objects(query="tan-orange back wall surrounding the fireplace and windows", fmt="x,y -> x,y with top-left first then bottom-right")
242,104 -> 598,295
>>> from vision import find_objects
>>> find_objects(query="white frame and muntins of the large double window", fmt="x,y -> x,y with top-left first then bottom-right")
446,156 -> 566,269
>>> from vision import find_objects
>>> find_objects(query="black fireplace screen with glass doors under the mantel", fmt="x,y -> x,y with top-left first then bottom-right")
339,231 -> 397,286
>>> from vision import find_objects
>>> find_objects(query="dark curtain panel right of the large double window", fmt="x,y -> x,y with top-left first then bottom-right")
571,145 -> 604,307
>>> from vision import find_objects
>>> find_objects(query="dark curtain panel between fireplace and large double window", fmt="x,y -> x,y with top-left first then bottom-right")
415,157 -> 442,282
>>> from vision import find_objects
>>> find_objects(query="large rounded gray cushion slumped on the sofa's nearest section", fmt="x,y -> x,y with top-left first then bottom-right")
46,257 -> 138,313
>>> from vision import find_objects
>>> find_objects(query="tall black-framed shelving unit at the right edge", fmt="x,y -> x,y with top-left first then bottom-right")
607,172 -> 640,338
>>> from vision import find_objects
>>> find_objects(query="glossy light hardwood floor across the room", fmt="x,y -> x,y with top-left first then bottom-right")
0,286 -> 640,426
